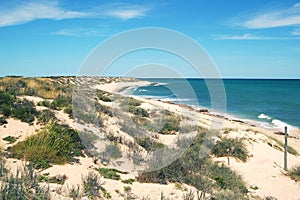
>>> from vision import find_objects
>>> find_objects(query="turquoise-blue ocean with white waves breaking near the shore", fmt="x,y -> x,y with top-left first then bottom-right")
127,79 -> 300,131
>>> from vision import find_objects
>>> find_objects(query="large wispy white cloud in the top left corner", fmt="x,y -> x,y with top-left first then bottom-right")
0,1 -> 90,27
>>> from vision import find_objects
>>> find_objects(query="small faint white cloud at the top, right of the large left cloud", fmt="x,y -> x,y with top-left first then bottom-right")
106,5 -> 149,20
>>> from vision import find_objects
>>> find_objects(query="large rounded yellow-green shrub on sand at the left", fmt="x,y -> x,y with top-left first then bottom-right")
10,124 -> 83,169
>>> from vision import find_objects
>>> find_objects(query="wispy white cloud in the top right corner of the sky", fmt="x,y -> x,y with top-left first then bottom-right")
241,3 -> 300,29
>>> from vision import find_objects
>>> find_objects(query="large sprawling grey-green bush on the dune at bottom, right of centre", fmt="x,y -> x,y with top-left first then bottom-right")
137,135 -> 248,196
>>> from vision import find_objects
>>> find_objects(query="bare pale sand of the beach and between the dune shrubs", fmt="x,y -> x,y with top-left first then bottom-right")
0,81 -> 300,200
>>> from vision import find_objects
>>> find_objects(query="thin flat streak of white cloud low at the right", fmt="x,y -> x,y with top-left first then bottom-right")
214,33 -> 300,40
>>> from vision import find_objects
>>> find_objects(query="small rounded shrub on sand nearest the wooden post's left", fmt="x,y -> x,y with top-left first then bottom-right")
212,138 -> 248,162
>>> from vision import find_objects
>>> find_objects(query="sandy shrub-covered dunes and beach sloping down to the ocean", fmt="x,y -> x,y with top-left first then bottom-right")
0,77 -> 300,200
